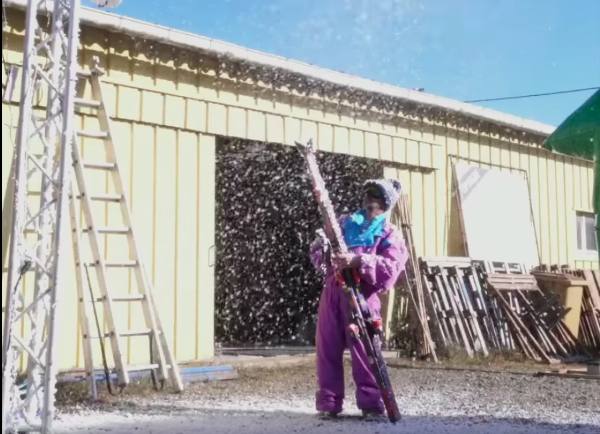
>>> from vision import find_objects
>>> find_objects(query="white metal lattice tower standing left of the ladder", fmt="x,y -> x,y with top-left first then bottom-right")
2,0 -> 79,433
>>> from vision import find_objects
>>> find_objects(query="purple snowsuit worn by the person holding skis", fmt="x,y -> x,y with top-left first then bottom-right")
310,225 -> 408,413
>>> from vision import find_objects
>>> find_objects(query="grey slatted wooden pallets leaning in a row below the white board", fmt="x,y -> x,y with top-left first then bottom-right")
420,257 -> 578,363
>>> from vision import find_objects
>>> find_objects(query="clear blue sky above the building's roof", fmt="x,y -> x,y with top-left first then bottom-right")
90,0 -> 600,125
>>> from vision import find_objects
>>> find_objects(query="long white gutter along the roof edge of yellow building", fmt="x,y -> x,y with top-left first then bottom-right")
4,0 -> 555,136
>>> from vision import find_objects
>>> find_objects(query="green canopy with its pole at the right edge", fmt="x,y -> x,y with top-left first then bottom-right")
544,90 -> 600,259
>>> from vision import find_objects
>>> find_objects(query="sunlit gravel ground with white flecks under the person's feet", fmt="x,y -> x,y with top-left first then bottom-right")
55,363 -> 600,434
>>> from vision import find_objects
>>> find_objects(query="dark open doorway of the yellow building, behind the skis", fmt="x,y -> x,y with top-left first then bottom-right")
215,138 -> 383,346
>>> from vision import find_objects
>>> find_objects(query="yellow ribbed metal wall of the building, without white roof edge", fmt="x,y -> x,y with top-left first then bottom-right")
2,11 -> 597,368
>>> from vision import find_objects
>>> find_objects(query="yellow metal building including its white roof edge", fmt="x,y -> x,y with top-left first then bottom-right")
2,1 -> 598,369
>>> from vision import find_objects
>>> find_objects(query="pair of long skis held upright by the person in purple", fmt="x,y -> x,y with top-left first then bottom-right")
296,140 -> 400,423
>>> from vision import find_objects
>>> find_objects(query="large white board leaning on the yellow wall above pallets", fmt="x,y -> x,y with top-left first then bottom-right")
454,162 -> 540,268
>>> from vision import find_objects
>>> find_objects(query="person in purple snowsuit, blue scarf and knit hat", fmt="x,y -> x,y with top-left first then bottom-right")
310,179 -> 408,417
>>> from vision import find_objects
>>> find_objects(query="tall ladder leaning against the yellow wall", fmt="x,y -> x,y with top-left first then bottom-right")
70,58 -> 183,398
